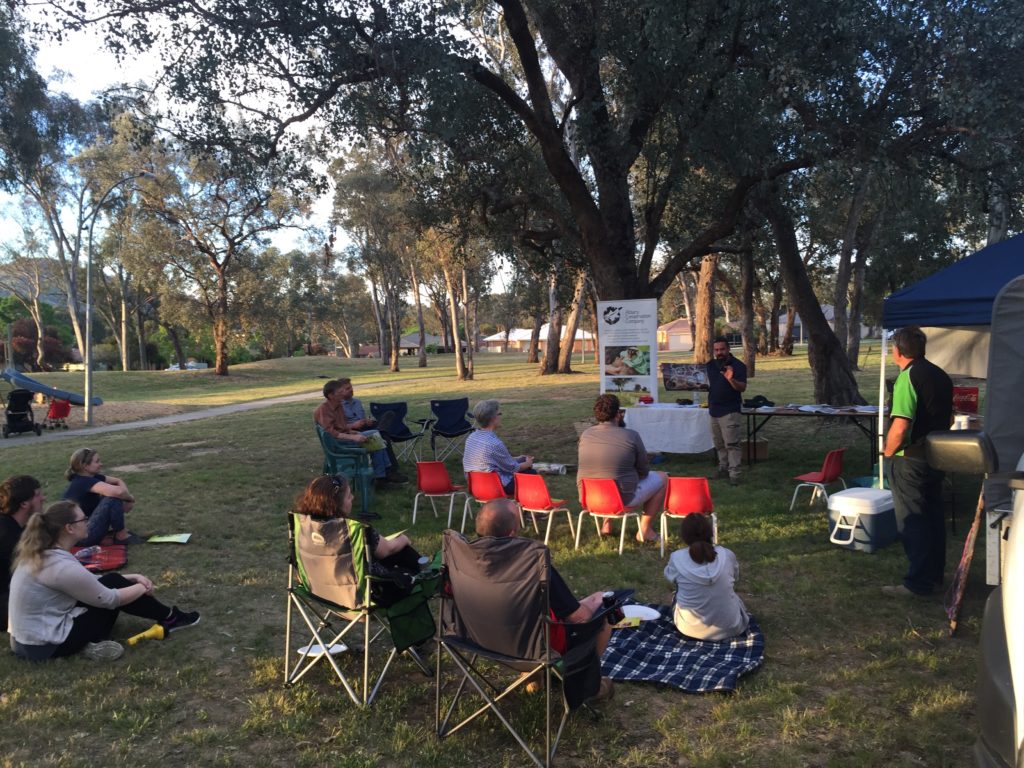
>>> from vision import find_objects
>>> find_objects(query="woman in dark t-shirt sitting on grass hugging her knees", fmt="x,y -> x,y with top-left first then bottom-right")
63,449 -> 142,547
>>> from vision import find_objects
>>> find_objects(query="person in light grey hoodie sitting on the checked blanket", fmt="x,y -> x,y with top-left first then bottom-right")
665,514 -> 750,640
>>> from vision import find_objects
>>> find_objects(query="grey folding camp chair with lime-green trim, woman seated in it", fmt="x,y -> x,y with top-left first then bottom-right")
285,513 -> 439,707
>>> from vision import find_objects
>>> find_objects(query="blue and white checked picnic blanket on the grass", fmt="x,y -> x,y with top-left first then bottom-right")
601,605 -> 765,693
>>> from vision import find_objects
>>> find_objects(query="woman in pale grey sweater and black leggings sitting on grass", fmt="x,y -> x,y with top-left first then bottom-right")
8,501 -> 199,662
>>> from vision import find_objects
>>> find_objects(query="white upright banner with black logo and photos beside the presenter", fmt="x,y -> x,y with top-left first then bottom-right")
597,299 -> 657,408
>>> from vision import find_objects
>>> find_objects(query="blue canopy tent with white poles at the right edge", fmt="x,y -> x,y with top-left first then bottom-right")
879,234 -> 1024,584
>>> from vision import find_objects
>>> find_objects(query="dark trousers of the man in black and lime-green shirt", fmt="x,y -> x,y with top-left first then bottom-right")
889,456 -> 946,595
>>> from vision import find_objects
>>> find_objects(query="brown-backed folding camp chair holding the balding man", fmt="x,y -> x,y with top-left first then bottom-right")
435,530 -> 632,766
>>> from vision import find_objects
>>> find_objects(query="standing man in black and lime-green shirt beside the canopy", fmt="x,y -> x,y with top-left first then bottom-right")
882,326 -> 953,597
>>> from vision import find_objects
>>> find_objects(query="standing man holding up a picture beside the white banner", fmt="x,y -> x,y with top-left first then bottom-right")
707,336 -> 746,485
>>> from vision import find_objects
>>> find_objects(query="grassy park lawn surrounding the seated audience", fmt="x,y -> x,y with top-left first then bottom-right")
0,349 -> 986,768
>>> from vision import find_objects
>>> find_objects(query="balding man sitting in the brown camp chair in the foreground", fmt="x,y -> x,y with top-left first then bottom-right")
476,499 -> 614,701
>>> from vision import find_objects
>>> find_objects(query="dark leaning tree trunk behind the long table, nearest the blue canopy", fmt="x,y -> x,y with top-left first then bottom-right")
759,189 -> 865,406
